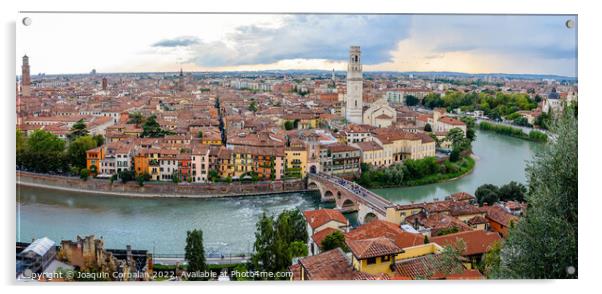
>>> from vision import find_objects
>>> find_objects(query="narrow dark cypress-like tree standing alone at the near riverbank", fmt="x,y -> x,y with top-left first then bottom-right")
185,229 -> 208,281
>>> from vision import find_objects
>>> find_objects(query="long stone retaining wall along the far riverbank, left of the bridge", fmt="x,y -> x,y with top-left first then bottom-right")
17,171 -> 307,198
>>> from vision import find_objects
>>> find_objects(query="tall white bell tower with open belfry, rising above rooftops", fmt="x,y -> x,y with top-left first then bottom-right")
345,46 -> 364,124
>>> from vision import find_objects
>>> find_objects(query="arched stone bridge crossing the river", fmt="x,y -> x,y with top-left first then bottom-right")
307,173 -> 394,224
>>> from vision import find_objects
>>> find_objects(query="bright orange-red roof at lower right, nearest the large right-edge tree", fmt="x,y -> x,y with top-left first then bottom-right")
431,230 -> 502,256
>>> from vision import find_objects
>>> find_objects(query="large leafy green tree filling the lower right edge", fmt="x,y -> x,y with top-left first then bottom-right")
499,109 -> 579,279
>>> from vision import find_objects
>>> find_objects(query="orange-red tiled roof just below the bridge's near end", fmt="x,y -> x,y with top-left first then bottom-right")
345,220 -> 424,248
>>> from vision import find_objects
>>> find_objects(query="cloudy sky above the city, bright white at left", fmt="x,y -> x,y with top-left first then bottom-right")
16,14 -> 577,76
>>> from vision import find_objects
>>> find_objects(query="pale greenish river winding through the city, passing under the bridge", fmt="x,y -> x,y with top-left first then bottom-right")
16,131 -> 542,255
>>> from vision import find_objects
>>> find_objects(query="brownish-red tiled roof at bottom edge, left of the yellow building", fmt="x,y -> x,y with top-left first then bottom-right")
299,248 -> 354,280
